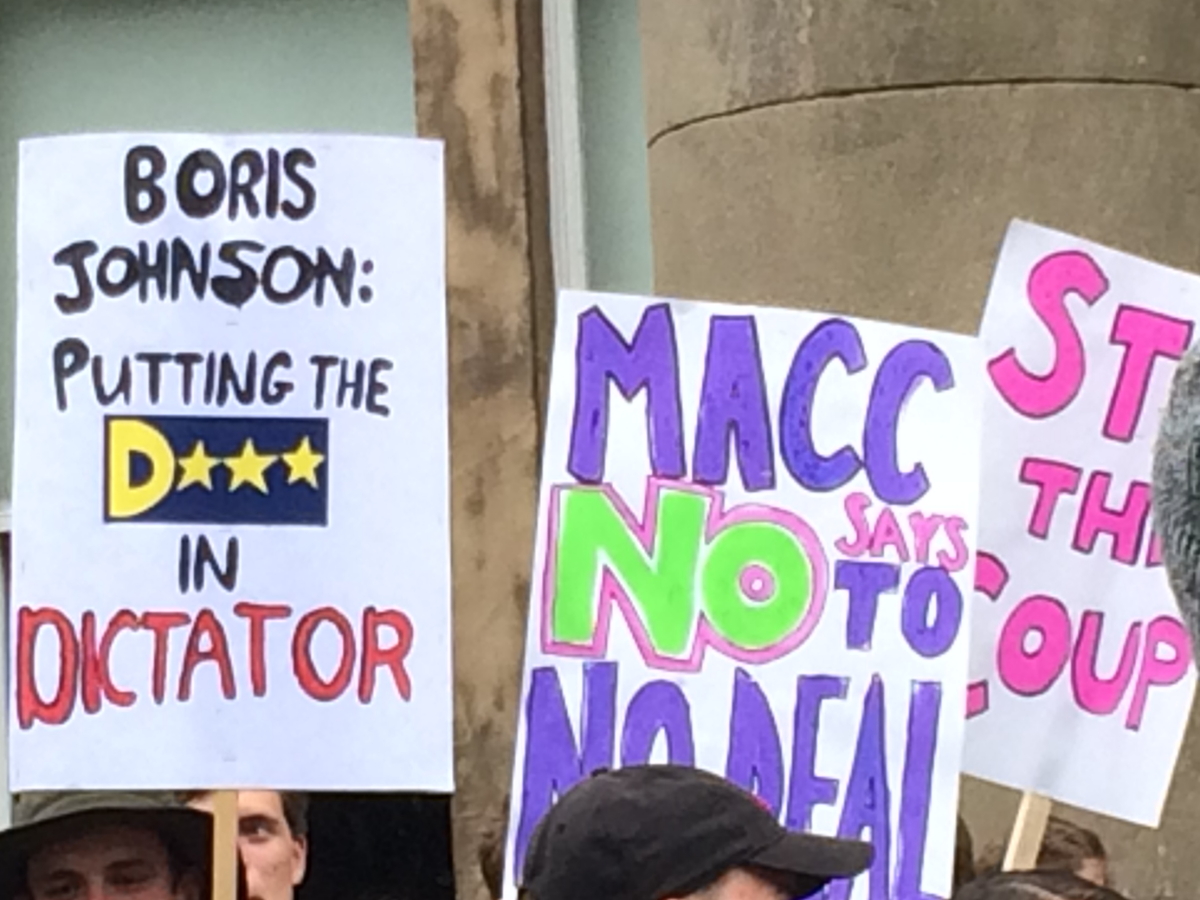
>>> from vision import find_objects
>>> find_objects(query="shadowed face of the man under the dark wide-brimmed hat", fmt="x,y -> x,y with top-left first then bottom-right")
26,826 -> 199,900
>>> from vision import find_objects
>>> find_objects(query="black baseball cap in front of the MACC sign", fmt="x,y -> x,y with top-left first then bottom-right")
521,766 -> 874,900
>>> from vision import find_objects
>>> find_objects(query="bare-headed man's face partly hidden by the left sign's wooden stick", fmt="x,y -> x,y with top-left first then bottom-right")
187,791 -> 308,900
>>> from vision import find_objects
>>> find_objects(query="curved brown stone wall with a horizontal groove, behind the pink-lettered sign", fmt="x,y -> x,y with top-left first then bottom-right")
641,0 -> 1200,898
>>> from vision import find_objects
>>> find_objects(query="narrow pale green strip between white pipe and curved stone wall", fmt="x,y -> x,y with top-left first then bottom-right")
577,0 -> 654,294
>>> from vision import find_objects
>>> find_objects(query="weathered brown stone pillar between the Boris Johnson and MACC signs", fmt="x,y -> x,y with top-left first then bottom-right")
408,0 -> 551,900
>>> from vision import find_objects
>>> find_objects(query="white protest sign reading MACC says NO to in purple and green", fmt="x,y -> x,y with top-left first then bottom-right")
508,293 -> 983,900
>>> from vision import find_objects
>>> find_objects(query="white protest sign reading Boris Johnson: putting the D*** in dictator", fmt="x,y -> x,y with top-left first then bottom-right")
10,134 -> 452,790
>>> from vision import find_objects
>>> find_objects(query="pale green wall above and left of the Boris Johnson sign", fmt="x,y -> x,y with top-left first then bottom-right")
0,0 -> 415,500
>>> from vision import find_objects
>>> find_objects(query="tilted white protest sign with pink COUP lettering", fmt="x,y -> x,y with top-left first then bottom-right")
965,222 -> 1200,826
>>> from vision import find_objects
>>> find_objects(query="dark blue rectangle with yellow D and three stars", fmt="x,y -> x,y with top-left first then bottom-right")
103,415 -> 329,526
